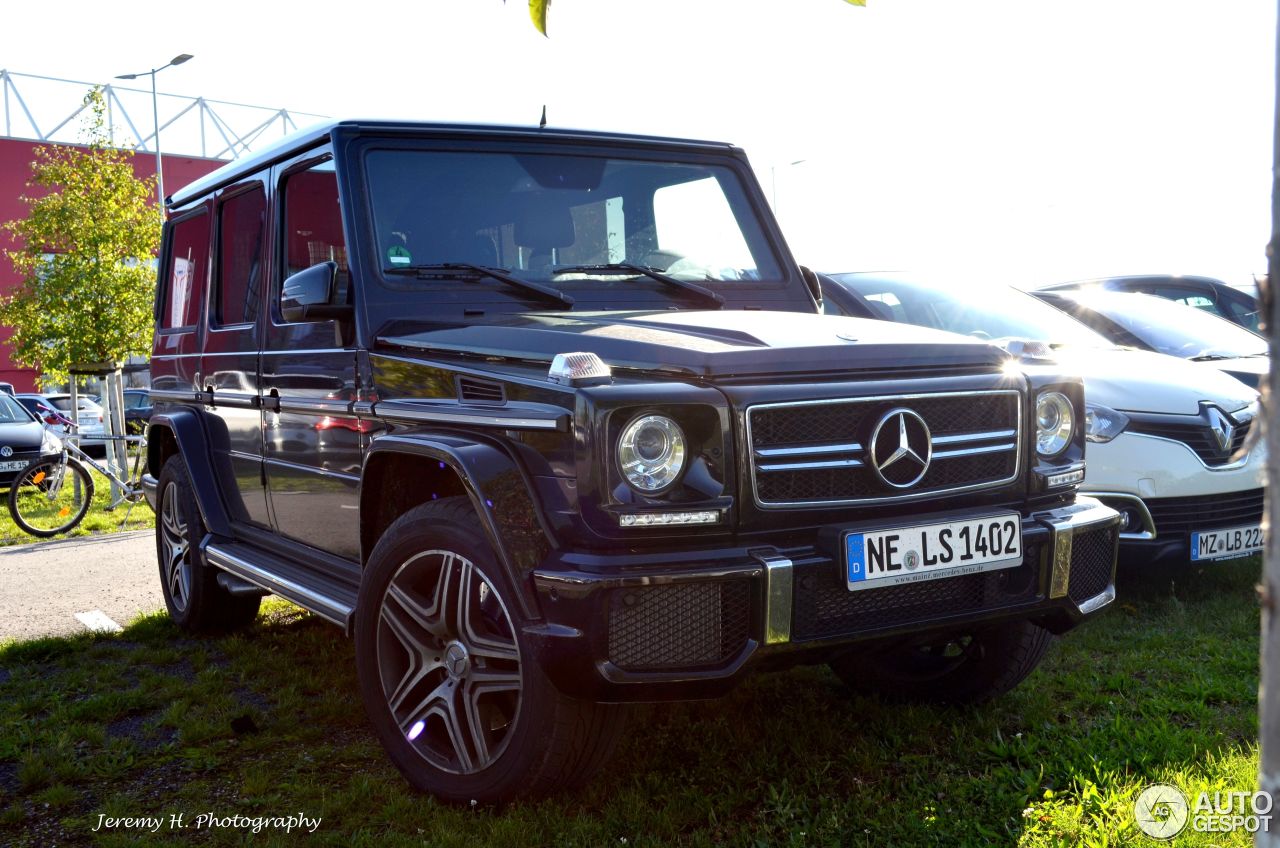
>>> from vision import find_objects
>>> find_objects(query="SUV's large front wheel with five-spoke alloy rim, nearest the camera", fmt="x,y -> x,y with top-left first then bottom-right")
355,497 -> 625,804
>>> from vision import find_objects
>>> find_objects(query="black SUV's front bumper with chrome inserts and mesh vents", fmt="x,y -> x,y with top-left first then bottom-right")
526,498 -> 1120,702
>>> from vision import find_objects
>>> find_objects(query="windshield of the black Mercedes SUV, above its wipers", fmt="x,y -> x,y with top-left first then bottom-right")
366,150 -> 782,297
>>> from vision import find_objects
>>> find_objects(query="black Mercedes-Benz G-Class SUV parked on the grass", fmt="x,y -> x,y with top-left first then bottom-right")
147,122 -> 1117,801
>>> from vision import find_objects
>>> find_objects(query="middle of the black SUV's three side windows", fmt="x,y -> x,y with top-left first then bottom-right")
214,186 -> 266,325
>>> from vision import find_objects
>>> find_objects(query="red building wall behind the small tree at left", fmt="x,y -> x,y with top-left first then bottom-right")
0,138 -> 227,392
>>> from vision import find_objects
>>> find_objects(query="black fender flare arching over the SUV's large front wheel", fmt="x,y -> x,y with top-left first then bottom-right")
360,433 -> 559,619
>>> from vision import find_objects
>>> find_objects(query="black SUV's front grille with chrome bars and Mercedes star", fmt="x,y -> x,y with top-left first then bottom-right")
746,389 -> 1021,509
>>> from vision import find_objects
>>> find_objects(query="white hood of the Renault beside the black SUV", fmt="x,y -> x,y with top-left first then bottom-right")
1034,348 -> 1258,415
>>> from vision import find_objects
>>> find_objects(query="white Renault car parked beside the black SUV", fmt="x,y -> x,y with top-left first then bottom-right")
823,273 -> 1266,562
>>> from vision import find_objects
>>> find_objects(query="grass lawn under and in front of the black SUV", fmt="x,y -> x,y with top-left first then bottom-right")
0,559 -> 1260,848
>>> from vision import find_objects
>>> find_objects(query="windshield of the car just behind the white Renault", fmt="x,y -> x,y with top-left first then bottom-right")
1076,292 -> 1267,359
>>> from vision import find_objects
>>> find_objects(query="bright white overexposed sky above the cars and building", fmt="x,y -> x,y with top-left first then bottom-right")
0,0 -> 1276,284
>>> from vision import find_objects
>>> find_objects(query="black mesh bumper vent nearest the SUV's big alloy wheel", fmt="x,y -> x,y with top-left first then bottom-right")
609,580 -> 751,671
